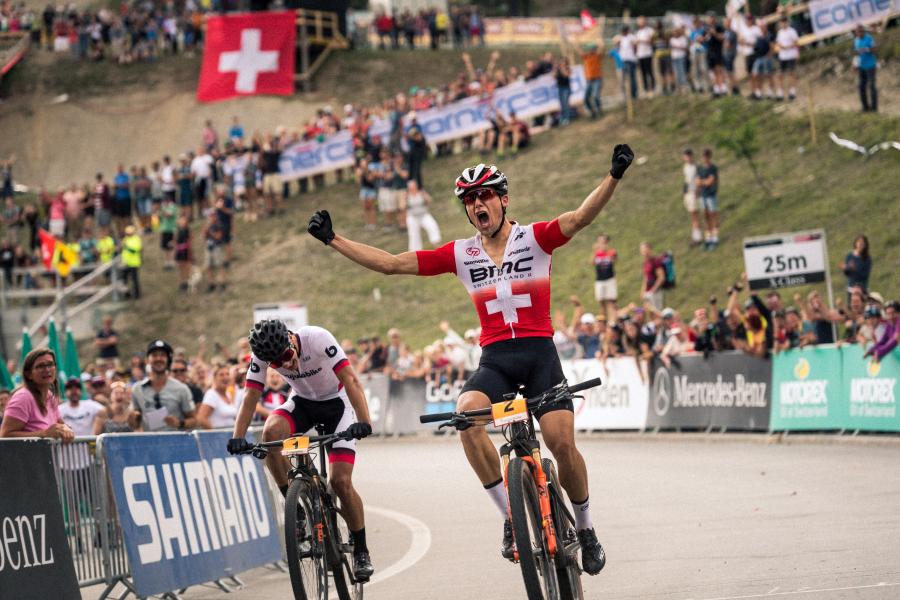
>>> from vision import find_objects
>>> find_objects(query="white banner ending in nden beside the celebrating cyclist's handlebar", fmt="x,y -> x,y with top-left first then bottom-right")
562,358 -> 650,430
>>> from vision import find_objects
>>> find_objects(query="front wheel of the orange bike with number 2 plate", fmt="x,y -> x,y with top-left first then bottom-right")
507,457 -> 559,600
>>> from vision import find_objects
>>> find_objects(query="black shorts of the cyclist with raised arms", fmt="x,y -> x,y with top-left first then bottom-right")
462,337 -> 574,420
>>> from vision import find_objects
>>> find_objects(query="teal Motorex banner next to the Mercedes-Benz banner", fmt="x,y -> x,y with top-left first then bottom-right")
769,345 -> 848,431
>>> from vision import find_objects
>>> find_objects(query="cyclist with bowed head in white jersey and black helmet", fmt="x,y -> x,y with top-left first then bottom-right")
228,319 -> 375,581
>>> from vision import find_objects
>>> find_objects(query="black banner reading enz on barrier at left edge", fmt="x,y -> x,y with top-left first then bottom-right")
0,440 -> 80,600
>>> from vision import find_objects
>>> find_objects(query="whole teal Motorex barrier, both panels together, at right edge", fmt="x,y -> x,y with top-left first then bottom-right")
771,344 -> 900,431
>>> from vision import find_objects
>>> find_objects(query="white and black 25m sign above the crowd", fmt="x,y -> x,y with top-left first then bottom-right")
744,230 -> 828,290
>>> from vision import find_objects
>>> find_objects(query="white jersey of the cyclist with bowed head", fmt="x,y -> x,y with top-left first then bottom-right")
244,325 -> 350,400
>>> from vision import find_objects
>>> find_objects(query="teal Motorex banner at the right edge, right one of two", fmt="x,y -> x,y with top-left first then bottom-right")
841,345 -> 900,431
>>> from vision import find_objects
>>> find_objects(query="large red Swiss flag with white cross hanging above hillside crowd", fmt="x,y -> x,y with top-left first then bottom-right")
197,11 -> 297,102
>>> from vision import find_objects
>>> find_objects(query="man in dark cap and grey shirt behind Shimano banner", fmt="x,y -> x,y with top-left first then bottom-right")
131,340 -> 197,431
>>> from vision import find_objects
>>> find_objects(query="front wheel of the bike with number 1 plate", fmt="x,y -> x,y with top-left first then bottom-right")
284,479 -> 328,600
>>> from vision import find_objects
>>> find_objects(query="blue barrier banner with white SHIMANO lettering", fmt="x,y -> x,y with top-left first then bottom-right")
100,432 -> 281,596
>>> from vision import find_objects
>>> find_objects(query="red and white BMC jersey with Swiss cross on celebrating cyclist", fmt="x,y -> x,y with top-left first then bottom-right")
416,219 -> 569,346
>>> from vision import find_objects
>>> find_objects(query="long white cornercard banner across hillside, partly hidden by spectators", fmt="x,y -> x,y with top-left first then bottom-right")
279,66 -> 585,180
